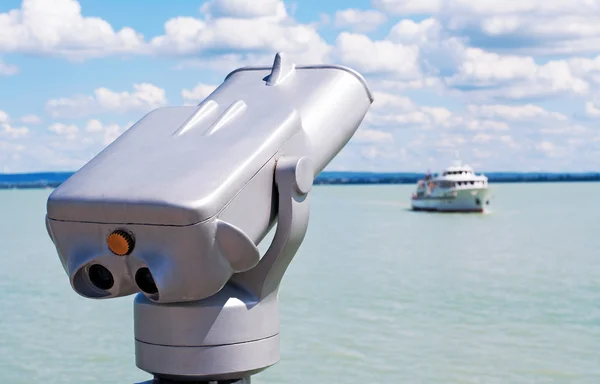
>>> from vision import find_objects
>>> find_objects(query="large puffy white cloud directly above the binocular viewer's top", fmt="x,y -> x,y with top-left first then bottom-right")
148,0 -> 331,65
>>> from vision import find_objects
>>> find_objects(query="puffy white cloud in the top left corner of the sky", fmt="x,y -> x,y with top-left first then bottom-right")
0,0 -> 143,59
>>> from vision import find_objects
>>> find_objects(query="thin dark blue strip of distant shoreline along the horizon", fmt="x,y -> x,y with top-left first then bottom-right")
0,172 -> 600,189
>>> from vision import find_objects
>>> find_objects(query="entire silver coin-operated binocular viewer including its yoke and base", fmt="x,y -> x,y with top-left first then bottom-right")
46,54 -> 373,381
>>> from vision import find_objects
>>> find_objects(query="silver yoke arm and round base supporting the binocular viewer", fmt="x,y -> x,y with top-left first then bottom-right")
134,157 -> 313,383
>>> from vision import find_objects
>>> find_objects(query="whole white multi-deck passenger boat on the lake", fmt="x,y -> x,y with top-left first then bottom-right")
412,160 -> 492,212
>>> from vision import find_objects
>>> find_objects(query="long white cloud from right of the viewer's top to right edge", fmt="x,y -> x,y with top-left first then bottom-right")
356,18 -> 600,100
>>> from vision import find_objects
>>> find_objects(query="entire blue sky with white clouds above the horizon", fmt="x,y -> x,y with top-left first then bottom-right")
0,0 -> 600,173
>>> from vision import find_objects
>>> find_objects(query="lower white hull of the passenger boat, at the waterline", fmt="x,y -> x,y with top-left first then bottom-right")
411,188 -> 491,213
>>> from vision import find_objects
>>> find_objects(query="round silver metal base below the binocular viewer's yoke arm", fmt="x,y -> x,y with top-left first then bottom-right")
134,284 -> 279,382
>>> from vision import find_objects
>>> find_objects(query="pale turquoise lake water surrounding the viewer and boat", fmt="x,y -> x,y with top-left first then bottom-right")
0,183 -> 600,384
